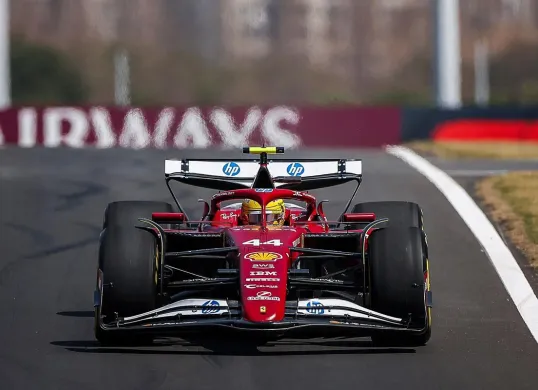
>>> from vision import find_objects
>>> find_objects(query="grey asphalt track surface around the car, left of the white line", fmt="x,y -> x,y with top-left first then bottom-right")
0,149 -> 538,390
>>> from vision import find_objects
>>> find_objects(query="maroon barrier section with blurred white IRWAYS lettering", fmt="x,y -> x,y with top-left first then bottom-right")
0,106 -> 401,149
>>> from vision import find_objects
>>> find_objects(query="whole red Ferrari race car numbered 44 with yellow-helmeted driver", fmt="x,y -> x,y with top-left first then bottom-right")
94,147 -> 432,346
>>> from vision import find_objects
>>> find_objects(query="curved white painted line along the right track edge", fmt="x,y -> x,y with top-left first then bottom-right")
386,146 -> 538,342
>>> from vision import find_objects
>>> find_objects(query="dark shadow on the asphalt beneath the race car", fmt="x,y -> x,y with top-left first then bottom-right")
51,339 -> 416,356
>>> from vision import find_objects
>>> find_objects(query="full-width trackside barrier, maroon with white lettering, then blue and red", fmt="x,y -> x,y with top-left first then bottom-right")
0,106 -> 538,149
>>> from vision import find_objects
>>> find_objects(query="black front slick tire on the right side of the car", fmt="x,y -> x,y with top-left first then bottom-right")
368,224 -> 431,347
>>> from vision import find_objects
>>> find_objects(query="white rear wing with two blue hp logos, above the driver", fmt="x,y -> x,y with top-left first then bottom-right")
164,159 -> 362,191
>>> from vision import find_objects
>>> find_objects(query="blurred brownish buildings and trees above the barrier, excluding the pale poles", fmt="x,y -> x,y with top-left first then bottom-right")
10,0 -> 538,106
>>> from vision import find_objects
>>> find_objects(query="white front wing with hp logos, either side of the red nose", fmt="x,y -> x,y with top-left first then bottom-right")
96,299 -> 426,337
